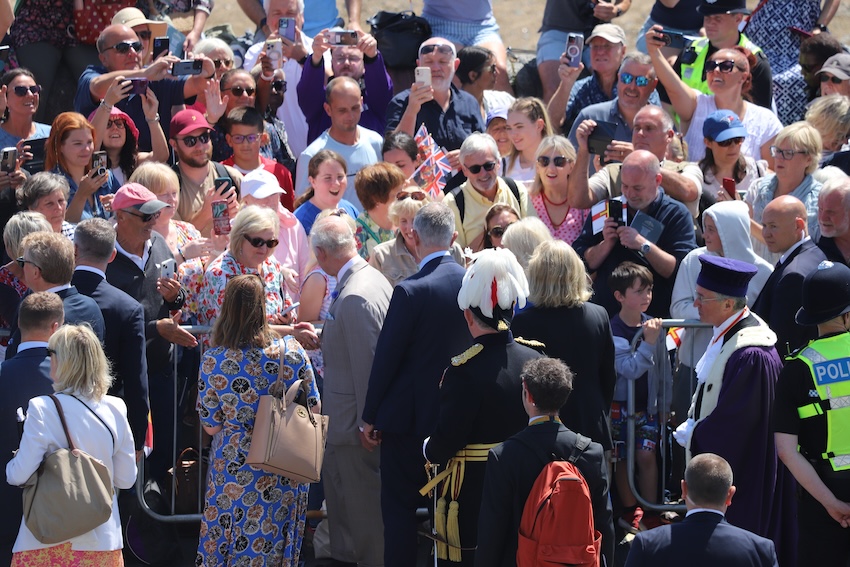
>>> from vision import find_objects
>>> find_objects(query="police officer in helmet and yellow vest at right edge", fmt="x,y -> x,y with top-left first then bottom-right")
774,260 -> 850,566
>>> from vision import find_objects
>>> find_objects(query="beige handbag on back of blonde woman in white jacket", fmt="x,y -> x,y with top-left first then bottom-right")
23,394 -> 115,544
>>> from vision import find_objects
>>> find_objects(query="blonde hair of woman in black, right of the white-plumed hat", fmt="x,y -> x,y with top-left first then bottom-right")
528,242 -> 593,307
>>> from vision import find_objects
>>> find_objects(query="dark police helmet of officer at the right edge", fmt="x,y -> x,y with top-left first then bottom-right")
794,260 -> 850,325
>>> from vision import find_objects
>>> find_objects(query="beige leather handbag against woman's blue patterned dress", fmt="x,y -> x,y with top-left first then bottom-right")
245,344 -> 328,482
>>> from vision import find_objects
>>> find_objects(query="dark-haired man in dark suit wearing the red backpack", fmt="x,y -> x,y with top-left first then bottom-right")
475,358 -> 614,567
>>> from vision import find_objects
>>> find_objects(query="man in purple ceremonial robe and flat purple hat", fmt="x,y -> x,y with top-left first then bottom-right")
674,255 -> 794,564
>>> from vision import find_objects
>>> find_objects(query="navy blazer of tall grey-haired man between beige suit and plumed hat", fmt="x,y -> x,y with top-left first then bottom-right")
363,255 -> 472,439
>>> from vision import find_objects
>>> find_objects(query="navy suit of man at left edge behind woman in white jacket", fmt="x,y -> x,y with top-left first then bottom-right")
0,347 -> 53,565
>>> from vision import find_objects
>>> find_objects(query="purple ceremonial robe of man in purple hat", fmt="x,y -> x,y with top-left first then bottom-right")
691,346 -> 797,567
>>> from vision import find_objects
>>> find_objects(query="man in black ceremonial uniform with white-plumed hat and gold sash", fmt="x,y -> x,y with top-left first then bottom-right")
422,248 -> 541,566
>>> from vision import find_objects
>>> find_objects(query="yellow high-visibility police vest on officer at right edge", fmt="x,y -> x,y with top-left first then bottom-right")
791,333 -> 850,471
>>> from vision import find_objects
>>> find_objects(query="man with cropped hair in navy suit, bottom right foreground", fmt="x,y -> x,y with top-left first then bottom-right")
626,453 -> 779,567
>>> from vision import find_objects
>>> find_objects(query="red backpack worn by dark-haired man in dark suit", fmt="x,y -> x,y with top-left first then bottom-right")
516,435 -> 602,567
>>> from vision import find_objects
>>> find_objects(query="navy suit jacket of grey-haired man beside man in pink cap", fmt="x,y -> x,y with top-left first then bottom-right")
71,270 -> 150,450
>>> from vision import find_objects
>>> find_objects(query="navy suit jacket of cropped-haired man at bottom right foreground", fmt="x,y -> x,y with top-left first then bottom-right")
626,512 -> 779,567
